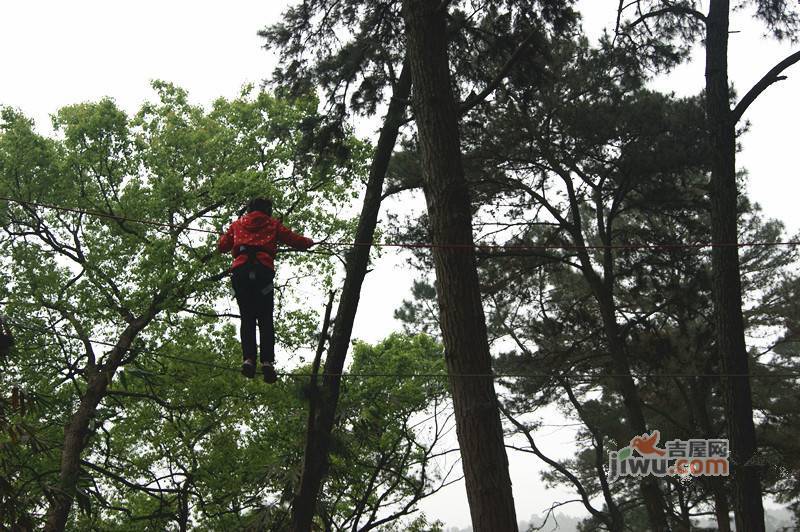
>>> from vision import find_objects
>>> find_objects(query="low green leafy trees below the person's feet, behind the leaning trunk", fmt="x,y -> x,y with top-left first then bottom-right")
18,330 -> 452,531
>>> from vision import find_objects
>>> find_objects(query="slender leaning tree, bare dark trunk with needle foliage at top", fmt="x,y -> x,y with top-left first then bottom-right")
262,0 -> 575,530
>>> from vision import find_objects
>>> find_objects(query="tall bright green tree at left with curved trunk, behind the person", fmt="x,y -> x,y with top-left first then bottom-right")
0,82 -> 364,530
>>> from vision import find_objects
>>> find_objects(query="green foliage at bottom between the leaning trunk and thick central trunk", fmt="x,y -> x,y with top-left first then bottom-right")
322,334 -> 451,530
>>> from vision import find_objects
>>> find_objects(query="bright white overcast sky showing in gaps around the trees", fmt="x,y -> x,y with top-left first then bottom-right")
0,0 -> 800,527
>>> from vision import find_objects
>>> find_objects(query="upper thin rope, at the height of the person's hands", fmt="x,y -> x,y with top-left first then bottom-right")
0,196 -> 800,251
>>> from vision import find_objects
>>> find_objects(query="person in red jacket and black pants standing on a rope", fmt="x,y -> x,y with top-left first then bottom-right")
217,198 -> 314,383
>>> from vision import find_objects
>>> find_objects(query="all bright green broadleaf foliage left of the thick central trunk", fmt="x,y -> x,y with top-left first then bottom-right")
0,82 -> 447,531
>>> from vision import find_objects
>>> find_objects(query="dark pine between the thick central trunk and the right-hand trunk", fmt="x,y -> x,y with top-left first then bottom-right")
399,31 -> 794,529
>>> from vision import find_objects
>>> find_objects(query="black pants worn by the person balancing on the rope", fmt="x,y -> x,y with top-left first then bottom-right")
231,263 -> 275,364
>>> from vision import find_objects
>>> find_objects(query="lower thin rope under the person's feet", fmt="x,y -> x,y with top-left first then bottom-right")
3,320 -> 800,380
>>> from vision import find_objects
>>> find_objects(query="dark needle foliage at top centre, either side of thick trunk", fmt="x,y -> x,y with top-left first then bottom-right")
259,0 -> 577,117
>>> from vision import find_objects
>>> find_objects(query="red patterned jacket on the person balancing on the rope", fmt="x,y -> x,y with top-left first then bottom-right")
217,211 -> 314,270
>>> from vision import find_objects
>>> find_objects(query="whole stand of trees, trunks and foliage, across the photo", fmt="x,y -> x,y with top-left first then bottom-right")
0,0 -> 800,532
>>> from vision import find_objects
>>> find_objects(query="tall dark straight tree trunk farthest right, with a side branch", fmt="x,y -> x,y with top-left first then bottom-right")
706,0 -> 764,532
